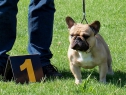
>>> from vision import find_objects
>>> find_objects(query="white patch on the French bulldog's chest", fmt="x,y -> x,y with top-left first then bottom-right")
77,51 -> 93,66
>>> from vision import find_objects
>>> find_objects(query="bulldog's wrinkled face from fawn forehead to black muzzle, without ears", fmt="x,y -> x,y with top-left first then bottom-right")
70,24 -> 91,51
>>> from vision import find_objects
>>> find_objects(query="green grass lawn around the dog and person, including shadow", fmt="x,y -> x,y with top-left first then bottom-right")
0,0 -> 126,95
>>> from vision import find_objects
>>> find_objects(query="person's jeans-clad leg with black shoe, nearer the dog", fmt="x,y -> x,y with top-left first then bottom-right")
28,0 -> 59,76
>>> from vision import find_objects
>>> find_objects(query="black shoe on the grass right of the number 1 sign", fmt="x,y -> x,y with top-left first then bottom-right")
42,64 -> 62,77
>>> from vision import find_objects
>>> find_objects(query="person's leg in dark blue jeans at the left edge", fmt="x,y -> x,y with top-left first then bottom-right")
0,0 -> 18,75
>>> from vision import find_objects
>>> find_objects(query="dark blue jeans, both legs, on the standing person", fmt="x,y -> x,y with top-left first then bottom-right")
0,0 -> 55,67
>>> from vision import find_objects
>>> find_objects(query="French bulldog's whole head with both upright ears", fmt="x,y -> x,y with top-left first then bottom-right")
66,17 -> 100,52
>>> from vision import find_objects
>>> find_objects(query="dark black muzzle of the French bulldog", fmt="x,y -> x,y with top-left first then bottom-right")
71,39 -> 89,52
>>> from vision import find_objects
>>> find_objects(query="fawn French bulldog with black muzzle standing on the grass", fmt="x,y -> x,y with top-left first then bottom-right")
66,17 -> 114,84
